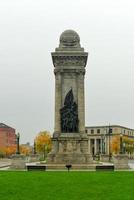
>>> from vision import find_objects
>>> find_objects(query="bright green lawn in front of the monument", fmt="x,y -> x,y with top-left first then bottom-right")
0,171 -> 134,200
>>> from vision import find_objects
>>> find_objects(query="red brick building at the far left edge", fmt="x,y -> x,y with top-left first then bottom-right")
0,123 -> 16,147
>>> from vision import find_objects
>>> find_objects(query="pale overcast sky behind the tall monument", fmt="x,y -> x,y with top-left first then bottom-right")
0,0 -> 134,143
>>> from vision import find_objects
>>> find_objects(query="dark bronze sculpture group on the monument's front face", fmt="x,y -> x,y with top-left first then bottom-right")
60,89 -> 78,133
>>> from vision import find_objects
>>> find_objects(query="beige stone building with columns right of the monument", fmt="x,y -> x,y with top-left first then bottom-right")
86,125 -> 134,155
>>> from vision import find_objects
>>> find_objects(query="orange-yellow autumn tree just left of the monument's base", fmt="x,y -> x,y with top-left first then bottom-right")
35,131 -> 51,153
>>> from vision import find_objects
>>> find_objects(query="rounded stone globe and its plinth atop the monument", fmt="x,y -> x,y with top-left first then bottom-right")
56,30 -> 84,51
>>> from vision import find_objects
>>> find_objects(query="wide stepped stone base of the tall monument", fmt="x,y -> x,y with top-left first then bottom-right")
47,133 -> 93,164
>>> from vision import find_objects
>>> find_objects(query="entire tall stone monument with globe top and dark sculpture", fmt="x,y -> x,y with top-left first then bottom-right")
47,30 -> 90,164
